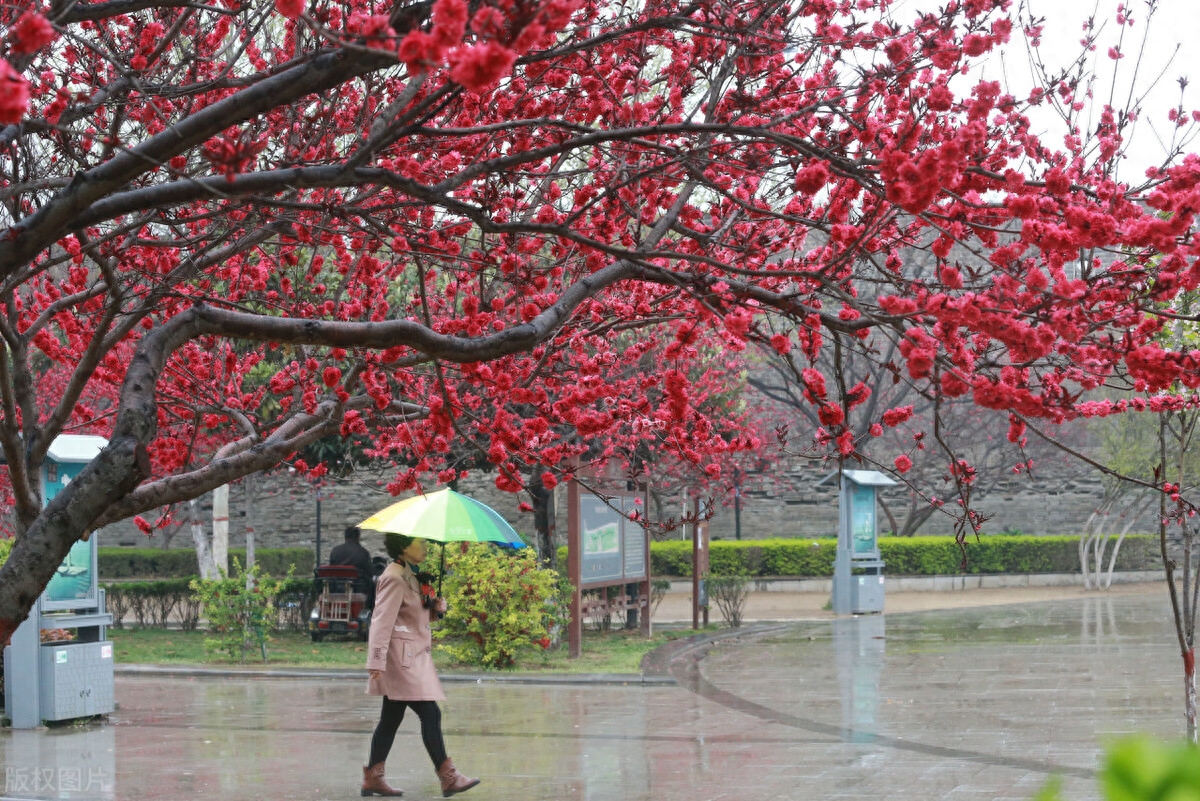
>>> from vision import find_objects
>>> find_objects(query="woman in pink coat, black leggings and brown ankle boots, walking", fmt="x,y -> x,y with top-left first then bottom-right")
362,534 -> 479,797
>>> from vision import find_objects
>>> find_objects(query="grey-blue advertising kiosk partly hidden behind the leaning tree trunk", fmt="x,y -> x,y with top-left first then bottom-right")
4,434 -> 114,729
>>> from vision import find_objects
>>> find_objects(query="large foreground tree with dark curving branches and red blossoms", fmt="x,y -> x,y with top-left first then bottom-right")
0,0 -> 1200,724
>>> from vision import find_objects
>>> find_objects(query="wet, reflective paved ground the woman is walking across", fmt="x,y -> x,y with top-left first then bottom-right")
0,590 -> 1183,801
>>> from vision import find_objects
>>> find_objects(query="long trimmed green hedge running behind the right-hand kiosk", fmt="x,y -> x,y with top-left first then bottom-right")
559,535 -> 1162,578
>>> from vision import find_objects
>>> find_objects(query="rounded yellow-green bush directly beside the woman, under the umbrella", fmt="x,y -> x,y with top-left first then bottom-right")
436,546 -> 570,668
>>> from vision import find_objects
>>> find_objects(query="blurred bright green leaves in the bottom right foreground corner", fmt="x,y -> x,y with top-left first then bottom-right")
1036,737 -> 1200,801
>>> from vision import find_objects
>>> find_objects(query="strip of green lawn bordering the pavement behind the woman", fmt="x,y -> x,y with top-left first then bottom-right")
108,628 -> 692,673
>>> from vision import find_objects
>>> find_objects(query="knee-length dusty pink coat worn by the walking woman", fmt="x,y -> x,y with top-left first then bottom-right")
367,562 -> 446,700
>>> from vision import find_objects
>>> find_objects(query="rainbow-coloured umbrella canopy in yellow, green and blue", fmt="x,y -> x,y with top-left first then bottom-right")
359,488 -> 526,548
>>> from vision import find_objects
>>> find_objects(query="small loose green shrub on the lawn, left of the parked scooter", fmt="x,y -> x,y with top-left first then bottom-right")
191,558 -> 292,664
